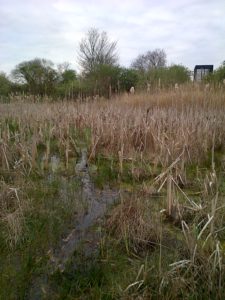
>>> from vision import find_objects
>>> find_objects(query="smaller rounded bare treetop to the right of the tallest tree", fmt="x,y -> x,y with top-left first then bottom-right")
131,49 -> 166,71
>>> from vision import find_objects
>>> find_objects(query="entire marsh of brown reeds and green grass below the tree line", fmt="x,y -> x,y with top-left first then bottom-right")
0,84 -> 225,299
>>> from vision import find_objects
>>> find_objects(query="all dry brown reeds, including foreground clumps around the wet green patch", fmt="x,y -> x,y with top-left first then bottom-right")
0,86 -> 225,299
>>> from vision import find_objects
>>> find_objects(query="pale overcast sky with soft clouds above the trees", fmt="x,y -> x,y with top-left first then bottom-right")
0,0 -> 225,73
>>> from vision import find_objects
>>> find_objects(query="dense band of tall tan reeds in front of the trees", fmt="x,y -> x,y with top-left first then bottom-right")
0,89 -> 225,167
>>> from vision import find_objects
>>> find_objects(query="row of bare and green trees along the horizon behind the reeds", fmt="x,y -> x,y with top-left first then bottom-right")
0,28 -> 225,99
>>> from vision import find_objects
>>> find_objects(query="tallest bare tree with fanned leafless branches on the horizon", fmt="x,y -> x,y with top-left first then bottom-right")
78,28 -> 118,73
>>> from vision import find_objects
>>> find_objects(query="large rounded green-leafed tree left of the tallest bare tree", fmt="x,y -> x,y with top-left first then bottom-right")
12,58 -> 58,95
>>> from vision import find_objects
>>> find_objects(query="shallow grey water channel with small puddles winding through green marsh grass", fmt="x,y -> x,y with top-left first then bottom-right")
27,149 -> 119,300
